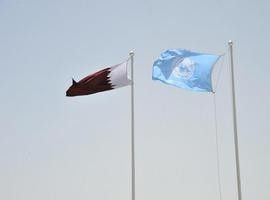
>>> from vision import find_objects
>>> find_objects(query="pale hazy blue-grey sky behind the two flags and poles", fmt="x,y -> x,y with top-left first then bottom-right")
0,0 -> 270,200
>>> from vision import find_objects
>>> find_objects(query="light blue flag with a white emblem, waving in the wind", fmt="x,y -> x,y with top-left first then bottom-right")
152,49 -> 220,92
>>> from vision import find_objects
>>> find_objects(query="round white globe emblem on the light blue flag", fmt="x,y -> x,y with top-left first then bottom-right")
173,58 -> 196,79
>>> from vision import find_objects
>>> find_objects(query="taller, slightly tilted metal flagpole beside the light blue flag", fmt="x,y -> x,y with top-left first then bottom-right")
228,40 -> 242,200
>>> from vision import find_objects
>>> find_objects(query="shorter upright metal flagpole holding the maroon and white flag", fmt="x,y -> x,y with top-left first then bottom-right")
129,51 -> 135,200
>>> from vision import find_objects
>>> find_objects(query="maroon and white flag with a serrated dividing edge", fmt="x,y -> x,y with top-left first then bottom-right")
66,62 -> 131,97
